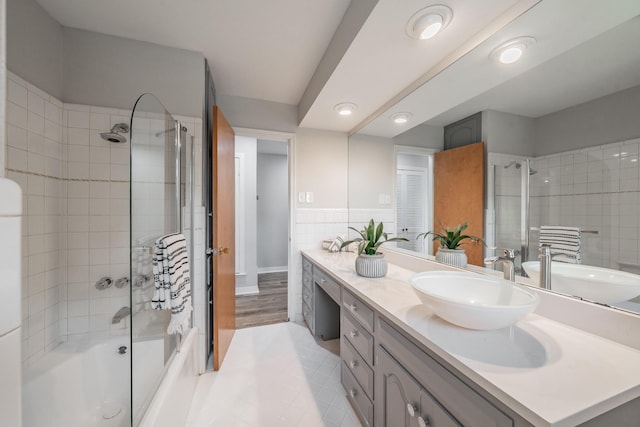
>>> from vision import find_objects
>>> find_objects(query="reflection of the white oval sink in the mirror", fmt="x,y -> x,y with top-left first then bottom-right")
522,261 -> 640,304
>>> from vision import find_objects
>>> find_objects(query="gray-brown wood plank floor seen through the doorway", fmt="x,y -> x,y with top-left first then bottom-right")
236,271 -> 288,329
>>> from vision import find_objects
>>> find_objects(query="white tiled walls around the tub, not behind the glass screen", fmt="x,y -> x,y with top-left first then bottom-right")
6,72 -> 204,366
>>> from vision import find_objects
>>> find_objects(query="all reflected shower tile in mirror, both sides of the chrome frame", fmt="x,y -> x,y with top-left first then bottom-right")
488,138 -> 640,271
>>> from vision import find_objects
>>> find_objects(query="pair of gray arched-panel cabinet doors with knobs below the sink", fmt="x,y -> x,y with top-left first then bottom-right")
375,346 -> 460,427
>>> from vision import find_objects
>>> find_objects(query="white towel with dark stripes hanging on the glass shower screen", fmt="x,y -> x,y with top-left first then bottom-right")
151,233 -> 192,334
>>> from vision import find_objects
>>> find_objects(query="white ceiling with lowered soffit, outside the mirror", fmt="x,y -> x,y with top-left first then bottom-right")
37,0 -> 537,132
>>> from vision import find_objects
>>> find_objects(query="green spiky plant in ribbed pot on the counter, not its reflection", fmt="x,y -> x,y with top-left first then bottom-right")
340,219 -> 407,277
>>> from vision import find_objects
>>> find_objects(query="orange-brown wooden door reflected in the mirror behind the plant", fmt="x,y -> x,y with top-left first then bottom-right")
433,142 -> 485,265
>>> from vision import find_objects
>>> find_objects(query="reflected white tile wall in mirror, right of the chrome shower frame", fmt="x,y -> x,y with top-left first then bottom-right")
531,138 -> 640,269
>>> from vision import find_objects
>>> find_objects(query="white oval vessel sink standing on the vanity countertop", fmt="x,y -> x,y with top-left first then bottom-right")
410,271 -> 539,330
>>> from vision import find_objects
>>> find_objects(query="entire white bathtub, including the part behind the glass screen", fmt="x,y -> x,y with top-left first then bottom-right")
22,328 -> 198,427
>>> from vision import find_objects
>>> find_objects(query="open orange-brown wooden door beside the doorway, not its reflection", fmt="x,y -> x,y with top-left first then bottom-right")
211,106 -> 236,371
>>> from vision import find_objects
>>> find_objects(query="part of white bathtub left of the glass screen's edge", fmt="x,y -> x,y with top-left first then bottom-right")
22,337 -> 131,427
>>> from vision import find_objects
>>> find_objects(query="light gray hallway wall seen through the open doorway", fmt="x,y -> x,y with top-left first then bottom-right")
257,152 -> 289,271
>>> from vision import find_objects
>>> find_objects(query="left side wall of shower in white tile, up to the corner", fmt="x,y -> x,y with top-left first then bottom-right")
6,72 -> 67,360
